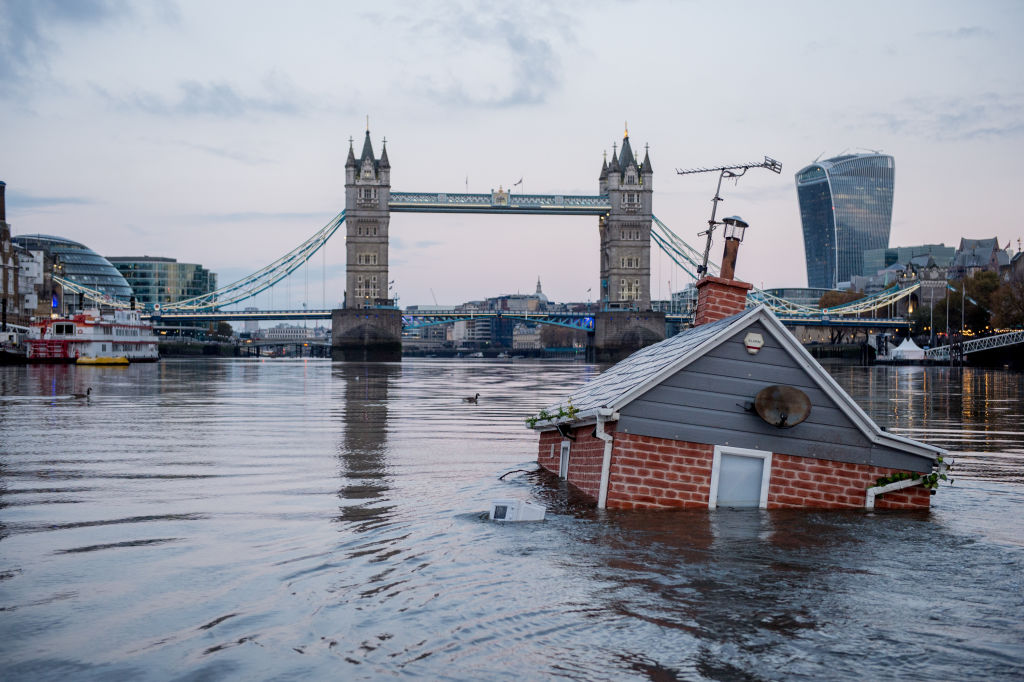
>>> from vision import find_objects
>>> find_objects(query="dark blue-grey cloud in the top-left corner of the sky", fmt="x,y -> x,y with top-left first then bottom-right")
0,0 -> 131,92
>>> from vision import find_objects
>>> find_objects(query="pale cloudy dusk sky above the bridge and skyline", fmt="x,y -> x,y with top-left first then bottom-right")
0,0 -> 1024,308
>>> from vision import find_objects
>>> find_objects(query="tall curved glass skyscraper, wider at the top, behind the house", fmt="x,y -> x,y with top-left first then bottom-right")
797,154 -> 895,289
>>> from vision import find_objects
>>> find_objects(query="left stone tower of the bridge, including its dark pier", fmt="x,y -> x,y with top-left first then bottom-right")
331,126 -> 401,360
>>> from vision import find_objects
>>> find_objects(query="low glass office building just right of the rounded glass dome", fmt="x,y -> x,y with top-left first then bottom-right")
109,256 -> 217,309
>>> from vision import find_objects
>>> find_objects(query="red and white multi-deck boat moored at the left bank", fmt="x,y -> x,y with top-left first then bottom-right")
25,308 -> 160,365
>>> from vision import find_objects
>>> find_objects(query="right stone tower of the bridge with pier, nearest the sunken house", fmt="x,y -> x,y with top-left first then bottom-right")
591,128 -> 665,361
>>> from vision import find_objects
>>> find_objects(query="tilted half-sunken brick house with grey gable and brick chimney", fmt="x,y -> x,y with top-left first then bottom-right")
527,276 -> 945,509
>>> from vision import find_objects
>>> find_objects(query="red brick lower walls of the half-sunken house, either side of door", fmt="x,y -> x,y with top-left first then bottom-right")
538,424 -> 932,509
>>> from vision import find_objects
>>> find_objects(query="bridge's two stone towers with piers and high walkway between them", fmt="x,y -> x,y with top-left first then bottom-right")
332,129 -> 665,359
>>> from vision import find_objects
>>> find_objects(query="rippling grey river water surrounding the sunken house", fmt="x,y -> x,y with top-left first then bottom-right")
0,358 -> 1024,680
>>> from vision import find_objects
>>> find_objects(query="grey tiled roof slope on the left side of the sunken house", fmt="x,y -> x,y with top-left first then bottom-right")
548,310 -> 751,413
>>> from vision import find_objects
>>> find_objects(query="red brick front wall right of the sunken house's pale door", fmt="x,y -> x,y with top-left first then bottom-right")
768,454 -> 932,509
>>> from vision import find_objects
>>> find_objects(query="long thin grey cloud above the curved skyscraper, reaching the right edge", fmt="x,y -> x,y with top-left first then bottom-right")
852,92 -> 1024,141
